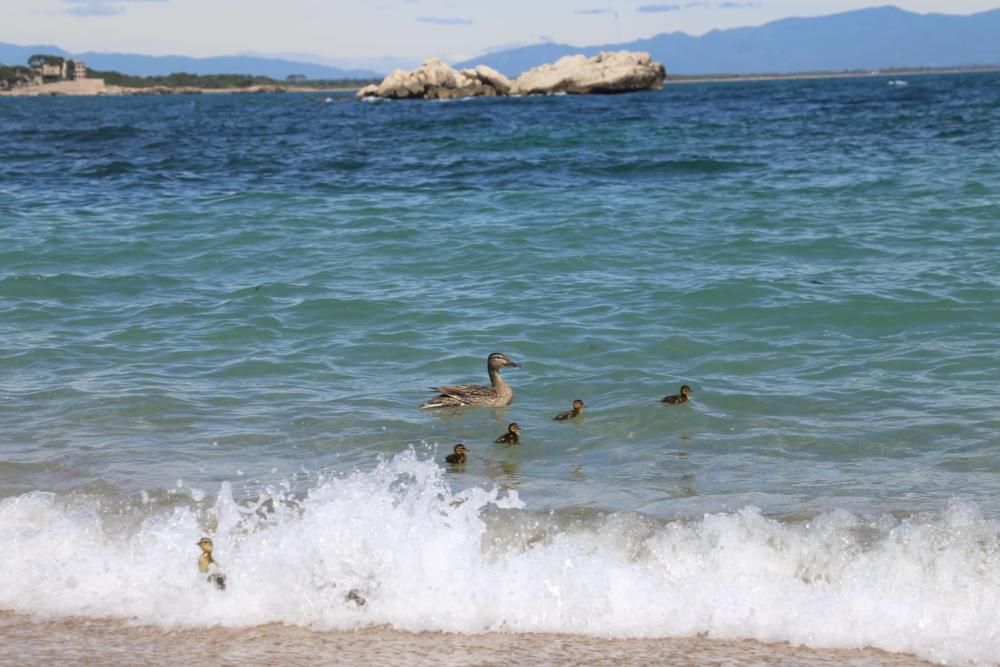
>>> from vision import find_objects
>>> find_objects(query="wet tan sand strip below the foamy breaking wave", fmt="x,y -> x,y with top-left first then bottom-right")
0,612 -> 930,667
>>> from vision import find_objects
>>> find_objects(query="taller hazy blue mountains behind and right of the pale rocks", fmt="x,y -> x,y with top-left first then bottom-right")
454,7 -> 1000,76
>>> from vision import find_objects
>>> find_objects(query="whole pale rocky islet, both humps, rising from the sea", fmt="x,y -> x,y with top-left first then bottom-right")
357,51 -> 667,100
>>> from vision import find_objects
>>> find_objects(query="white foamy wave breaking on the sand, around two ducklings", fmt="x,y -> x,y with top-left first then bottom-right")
0,452 -> 1000,662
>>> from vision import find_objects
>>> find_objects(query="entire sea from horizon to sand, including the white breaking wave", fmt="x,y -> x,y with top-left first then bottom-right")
0,73 -> 1000,664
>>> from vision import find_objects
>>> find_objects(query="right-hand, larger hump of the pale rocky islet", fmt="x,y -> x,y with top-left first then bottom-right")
511,51 -> 667,95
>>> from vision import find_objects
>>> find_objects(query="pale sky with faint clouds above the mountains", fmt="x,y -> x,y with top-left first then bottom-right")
0,0 -> 1000,67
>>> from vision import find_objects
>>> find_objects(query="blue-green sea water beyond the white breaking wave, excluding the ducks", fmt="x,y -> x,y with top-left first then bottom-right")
0,74 -> 1000,655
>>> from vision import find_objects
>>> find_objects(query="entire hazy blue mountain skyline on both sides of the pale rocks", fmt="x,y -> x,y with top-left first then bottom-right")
0,7 -> 1000,79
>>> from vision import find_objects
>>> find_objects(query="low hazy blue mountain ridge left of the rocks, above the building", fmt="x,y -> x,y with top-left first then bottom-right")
0,42 -> 382,79
